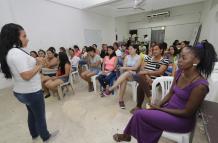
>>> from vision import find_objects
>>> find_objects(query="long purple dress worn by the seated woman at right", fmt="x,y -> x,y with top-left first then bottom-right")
124,71 -> 208,143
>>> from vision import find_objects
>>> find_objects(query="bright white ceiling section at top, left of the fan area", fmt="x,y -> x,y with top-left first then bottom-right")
49,0 -> 111,9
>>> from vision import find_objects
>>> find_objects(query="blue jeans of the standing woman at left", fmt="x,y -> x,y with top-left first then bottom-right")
14,90 -> 50,141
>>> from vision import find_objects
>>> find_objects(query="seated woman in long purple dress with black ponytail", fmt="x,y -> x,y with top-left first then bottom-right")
114,41 -> 217,143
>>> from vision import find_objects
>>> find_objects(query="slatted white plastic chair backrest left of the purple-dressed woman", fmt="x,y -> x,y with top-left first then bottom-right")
151,76 -> 173,104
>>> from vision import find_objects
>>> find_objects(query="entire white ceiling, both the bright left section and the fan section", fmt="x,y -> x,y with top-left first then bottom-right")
48,0 -> 207,17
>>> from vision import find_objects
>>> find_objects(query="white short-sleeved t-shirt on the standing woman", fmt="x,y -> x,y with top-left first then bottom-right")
6,48 -> 42,93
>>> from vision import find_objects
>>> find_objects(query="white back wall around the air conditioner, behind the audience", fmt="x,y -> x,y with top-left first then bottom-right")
115,3 -> 203,44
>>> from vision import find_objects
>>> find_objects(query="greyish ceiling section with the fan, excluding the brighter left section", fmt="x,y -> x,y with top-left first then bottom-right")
86,0 -> 207,17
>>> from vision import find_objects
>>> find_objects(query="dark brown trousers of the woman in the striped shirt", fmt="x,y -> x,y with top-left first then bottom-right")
133,74 -> 151,108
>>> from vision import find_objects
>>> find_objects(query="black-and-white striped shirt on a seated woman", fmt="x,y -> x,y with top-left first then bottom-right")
144,56 -> 169,80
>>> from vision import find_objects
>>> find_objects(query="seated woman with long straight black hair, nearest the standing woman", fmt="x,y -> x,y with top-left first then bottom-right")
45,52 -> 71,94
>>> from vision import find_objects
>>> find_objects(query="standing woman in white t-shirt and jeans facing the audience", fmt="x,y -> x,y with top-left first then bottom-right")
0,23 -> 58,142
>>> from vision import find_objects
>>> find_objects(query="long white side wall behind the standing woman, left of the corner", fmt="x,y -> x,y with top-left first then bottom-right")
0,0 -> 115,89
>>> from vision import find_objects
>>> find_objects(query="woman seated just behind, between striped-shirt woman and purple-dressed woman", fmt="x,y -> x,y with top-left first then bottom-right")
164,46 -> 178,76
